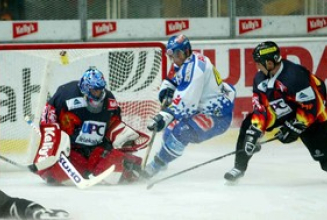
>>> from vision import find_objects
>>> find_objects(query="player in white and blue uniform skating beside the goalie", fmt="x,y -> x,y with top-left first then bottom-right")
143,35 -> 236,178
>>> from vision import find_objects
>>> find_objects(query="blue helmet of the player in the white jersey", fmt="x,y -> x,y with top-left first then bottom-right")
166,34 -> 192,56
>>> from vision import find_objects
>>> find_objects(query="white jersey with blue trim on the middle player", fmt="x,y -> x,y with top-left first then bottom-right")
168,52 -> 224,119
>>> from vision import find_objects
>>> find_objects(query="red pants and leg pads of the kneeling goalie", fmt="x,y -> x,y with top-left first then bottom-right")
38,147 -> 142,184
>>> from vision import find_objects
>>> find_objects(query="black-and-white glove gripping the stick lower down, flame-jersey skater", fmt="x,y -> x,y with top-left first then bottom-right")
244,125 -> 262,156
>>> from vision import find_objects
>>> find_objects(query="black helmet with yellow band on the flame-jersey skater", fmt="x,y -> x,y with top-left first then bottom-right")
252,41 -> 282,67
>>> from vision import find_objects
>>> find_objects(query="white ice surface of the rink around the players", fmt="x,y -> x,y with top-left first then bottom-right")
0,129 -> 327,220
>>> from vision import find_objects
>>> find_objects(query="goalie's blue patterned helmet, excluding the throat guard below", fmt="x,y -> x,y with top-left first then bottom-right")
78,67 -> 107,101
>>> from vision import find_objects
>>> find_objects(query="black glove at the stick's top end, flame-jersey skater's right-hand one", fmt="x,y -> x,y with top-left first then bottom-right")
276,120 -> 307,144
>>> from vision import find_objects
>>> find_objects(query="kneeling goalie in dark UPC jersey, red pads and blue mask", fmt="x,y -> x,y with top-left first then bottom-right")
34,67 -> 149,184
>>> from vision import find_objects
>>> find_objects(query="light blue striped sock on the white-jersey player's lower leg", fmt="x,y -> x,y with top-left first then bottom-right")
157,133 -> 186,163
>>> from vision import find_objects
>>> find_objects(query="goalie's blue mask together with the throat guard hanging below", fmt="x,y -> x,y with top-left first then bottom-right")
78,67 -> 107,113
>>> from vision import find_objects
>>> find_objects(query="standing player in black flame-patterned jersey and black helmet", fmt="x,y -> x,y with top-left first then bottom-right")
224,41 -> 327,182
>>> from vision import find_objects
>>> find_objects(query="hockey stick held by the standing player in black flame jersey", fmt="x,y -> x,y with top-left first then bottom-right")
146,136 -> 278,189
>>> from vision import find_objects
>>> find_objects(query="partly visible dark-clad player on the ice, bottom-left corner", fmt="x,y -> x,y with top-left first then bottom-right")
0,190 -> 69,220
